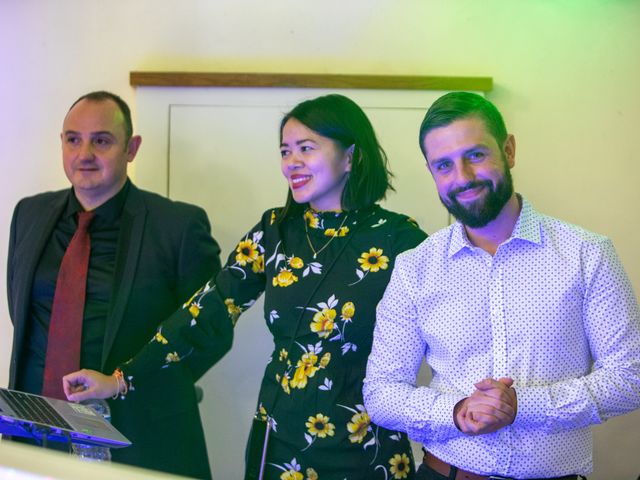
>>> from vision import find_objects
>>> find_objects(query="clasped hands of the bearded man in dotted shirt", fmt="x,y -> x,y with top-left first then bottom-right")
453,377 -> 518,435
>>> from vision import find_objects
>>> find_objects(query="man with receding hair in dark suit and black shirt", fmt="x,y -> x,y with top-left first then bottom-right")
7,92 -> 220,478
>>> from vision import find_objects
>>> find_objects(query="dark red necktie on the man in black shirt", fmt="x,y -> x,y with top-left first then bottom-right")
42,212 -> 94,400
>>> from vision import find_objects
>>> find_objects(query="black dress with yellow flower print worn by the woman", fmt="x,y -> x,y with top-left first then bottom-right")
123,205 -> 426,480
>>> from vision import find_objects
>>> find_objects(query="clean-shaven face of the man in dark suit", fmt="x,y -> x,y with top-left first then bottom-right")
60,99 -> 140,207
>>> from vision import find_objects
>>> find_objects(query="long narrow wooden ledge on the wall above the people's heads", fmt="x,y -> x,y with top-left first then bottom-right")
129,72 -> 493,92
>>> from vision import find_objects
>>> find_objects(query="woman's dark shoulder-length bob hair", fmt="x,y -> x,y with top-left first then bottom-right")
280,94 -> 393,219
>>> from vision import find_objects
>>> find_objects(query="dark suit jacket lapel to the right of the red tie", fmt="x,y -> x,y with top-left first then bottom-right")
102,184 -> 147,369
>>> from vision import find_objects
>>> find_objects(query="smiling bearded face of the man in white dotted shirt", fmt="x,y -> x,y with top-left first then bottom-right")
423,117 -> 515,228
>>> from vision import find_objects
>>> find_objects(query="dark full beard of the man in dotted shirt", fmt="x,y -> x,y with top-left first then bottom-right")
440,165 -> 513,228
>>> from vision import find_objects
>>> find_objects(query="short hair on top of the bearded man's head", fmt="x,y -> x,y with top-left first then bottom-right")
418,92 -> 507,158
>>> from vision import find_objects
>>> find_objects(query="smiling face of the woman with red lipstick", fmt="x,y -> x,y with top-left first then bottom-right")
280,118 -> 353,211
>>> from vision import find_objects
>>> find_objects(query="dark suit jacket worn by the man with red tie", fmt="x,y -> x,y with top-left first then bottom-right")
7,185 -> 220,478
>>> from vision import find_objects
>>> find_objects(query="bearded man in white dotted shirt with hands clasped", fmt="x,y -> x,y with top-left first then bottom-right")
364,92 -> 640,480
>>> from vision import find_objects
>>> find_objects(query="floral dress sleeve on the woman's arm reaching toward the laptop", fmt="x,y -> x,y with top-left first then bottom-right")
120,214 -> 273,386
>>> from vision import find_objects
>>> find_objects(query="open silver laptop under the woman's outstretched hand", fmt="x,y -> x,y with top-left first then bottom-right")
0,388 -> 131,448
